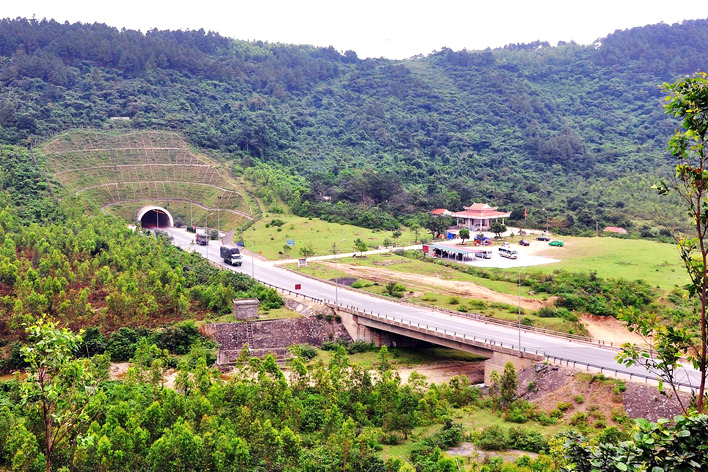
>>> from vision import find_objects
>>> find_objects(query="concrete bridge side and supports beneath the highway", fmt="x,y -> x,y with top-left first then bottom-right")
329,305 -> 545,385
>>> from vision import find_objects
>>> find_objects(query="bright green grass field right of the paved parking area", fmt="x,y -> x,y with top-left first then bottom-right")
524,237 -> 688,291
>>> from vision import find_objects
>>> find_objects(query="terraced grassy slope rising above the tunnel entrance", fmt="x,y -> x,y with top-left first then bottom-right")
41,131 -> 258,231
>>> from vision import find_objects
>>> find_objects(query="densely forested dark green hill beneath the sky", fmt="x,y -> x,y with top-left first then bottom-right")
0,19 -> 708,235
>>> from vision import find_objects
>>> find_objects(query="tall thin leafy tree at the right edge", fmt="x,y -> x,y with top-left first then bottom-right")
619,73 -> 708,413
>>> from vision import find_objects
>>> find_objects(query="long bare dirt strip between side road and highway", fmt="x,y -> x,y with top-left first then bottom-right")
318,262 -> 549,311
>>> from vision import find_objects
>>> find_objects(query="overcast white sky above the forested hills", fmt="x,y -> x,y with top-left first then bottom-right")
0,0 -> 708,59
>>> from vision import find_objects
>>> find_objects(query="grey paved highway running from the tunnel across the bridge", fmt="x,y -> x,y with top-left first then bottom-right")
167,228 -> 699,385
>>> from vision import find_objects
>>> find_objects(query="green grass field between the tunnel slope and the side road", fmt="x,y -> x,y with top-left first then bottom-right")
243,213 -> 425,260
